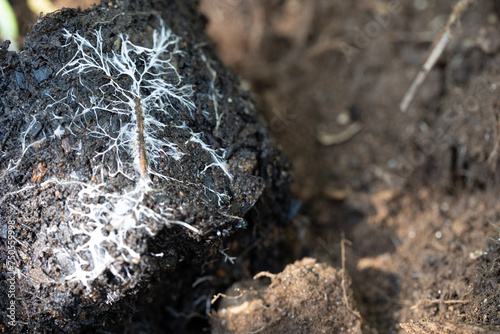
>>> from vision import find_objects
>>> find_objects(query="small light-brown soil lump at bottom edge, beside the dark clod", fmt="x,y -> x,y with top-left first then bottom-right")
212,258 -> 361,334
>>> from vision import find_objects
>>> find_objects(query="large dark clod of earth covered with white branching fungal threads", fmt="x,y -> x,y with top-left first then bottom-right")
0,1 -> 289,333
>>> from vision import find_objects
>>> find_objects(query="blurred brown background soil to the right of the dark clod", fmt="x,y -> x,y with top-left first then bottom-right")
3,0 -> 500,333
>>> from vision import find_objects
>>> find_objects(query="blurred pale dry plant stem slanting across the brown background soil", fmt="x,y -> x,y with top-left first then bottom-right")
399,0 -> 472,112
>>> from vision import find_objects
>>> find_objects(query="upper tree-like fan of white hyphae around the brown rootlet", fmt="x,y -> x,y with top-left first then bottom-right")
60,25 -> 196,184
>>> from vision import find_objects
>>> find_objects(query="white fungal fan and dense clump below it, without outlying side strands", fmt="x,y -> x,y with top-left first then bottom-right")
53,24 -> 200,289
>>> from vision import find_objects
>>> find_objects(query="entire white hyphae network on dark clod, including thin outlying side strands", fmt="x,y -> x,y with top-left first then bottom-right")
23,23 -> 232,289
